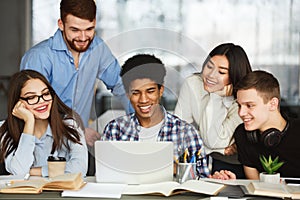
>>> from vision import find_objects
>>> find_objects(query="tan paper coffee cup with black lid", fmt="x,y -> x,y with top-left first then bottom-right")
47,156 -> 66,178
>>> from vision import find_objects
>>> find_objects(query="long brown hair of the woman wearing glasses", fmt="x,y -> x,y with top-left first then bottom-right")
0,70 -> 84,162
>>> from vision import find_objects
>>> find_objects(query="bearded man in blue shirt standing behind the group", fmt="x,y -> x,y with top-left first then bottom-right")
20,0 -> 133,146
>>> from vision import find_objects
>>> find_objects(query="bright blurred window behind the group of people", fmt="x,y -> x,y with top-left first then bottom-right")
33,0 -> 300,112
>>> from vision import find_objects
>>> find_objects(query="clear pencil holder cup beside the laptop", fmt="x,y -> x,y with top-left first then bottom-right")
175,163 -> 197,183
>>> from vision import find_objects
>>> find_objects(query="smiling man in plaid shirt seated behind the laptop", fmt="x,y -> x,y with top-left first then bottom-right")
102,54 -> 209,176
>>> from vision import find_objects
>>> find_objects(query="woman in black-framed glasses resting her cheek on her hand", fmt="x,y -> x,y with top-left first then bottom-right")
0,70 -> 88,176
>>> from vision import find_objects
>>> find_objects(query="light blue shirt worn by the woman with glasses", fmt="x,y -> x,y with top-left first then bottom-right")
5,120 -> 88,176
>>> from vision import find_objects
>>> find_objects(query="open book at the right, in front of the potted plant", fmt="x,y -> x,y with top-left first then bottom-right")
243,182 -> 300,199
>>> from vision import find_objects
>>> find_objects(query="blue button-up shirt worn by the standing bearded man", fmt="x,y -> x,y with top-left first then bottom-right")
20,29 -> 132,126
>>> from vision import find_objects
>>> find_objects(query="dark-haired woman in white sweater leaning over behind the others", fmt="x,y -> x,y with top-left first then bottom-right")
175,43 -> 252,178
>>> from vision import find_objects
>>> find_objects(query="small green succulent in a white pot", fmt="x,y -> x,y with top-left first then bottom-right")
259,155 -> 284,183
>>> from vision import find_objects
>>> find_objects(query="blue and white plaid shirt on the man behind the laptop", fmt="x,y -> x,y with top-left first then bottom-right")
102,108 -> 209,176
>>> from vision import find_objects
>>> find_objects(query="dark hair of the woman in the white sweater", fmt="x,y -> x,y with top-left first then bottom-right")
202,43 -> 252,97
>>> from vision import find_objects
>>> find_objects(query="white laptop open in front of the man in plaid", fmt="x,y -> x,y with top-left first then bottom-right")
95,141 -> 173,184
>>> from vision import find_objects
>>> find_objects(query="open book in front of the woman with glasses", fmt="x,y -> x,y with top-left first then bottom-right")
0,173 -> 85,194
